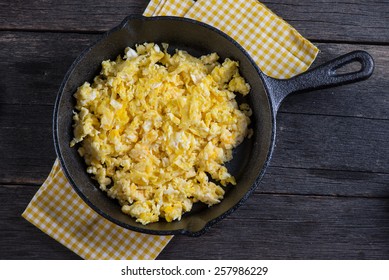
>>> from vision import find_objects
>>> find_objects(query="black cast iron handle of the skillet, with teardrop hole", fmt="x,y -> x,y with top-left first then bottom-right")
264,51 -> 374,112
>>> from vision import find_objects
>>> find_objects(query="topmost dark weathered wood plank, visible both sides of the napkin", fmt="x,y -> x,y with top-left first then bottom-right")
0,0 -> 389,43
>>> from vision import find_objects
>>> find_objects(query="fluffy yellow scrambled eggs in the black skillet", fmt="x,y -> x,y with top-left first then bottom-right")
70,43 -> 252,224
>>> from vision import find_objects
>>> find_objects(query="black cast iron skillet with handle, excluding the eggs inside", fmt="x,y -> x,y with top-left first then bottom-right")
53,16 -> 374,236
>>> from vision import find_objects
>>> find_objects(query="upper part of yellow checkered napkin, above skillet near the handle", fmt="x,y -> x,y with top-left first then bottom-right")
144,0 -> 318,79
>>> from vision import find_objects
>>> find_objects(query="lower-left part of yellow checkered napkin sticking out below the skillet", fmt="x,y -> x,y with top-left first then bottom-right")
22,159 -> 171,259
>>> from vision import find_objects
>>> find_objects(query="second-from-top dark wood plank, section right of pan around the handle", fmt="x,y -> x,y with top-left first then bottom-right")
280,43 -> 389,120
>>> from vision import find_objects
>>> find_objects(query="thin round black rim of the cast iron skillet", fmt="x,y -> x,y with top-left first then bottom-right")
53,15 -> 276,236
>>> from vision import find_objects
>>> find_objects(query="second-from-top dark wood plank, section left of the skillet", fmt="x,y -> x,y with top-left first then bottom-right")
0,32 -> 100,106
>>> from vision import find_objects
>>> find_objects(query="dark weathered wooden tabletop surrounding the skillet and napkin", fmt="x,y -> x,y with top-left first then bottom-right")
0,0 -> 389,259
